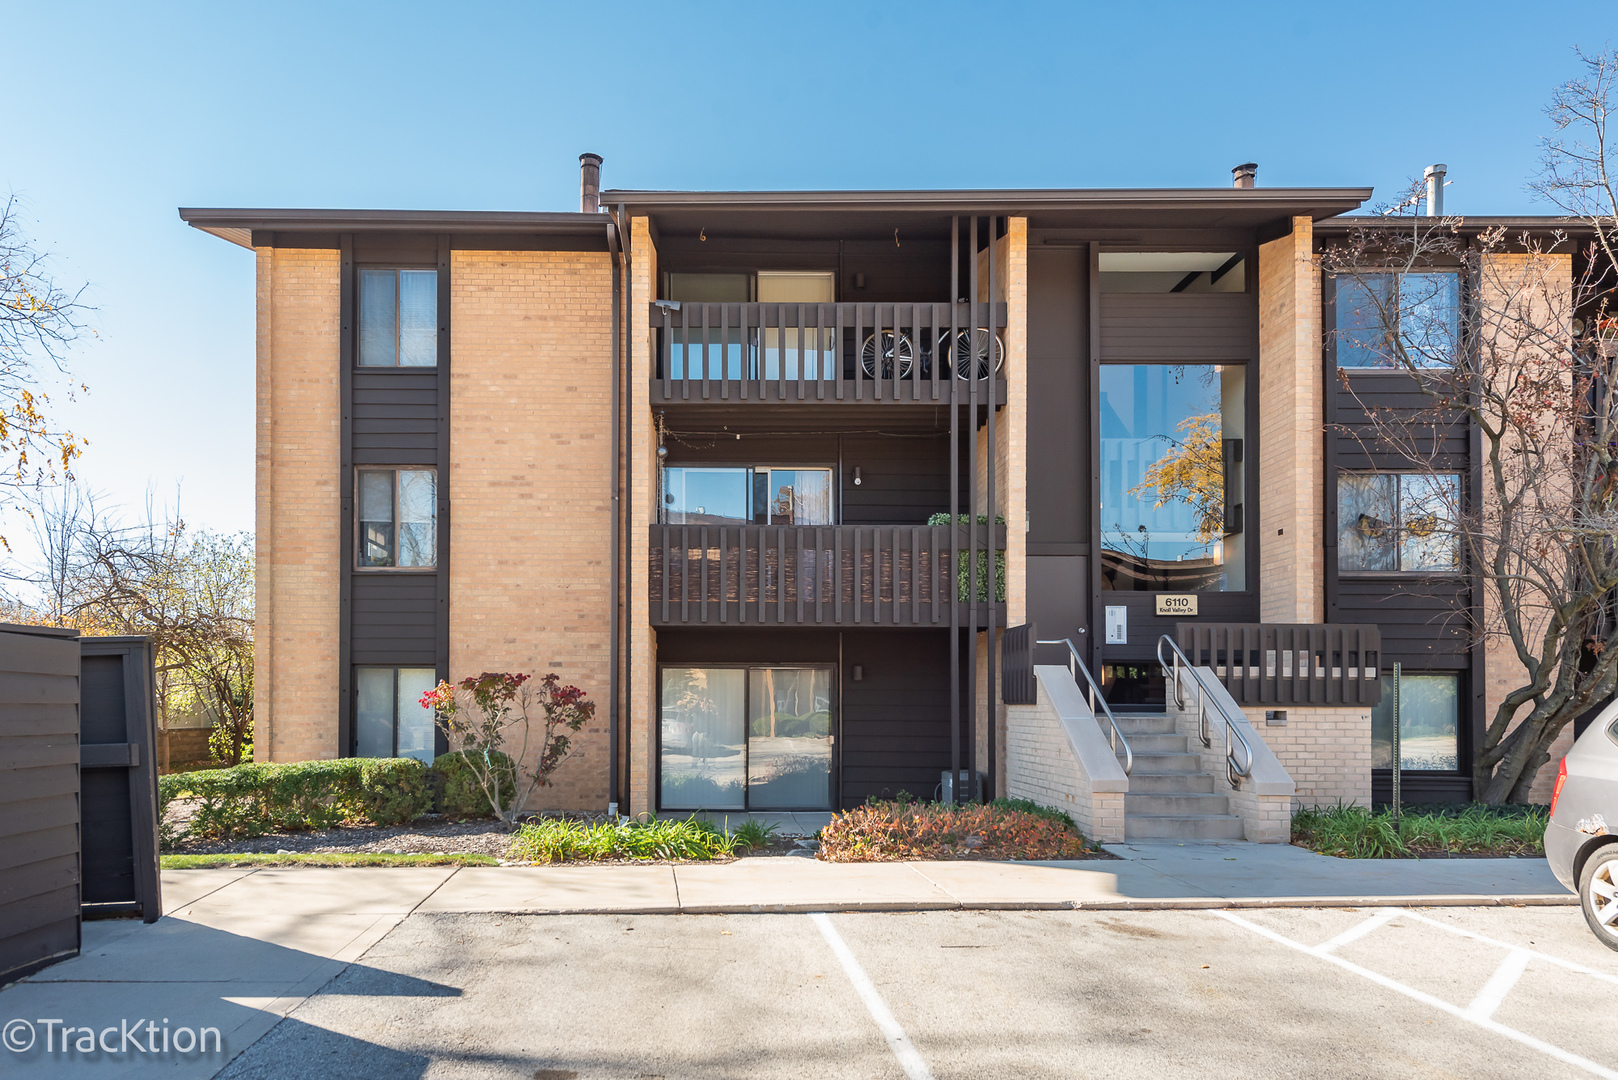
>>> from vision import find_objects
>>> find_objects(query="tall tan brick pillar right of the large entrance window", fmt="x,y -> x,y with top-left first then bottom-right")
1247,217 -> 1325,622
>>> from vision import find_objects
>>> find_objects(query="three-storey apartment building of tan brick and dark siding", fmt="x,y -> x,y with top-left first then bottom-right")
181,155 -> 1585,832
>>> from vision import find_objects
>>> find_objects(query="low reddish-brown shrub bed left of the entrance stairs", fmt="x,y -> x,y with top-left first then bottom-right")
819,800 -> 1095,863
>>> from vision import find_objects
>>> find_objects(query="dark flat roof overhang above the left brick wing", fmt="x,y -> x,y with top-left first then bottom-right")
180,206 -> 612,251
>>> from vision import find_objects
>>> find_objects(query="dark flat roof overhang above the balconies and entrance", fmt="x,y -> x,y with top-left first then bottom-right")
602,188 -> 1370,240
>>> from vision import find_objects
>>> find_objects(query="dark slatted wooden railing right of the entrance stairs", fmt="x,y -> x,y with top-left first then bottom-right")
1175,622 -> 1382,704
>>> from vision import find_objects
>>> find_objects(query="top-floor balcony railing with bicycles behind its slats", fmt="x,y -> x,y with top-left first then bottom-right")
650,301 -> 1006,406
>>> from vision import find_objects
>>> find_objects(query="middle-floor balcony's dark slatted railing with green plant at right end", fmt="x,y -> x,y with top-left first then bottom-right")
649,523 -> 1006,628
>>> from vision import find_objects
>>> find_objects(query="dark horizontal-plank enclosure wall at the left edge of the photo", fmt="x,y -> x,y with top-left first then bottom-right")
0,631 -> 79,983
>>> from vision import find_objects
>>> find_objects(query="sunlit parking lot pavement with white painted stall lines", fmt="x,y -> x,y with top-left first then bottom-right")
199,907 -> 1618,1080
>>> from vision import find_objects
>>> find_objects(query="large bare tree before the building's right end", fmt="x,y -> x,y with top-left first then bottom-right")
1320,52 -> 1618,803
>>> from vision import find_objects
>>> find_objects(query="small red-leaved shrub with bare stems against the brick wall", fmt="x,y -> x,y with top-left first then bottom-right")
421,672 -> 595,829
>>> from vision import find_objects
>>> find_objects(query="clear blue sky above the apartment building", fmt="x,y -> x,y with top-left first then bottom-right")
0,0 -> 1618,553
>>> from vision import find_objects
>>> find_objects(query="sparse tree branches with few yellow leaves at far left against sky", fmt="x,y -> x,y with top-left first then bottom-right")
0,196 -> 91,544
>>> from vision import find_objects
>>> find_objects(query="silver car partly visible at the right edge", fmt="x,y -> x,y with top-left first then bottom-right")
1545,701 -> 1618,950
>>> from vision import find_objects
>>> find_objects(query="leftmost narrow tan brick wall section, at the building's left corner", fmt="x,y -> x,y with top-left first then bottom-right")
252,248 -> 341,761
